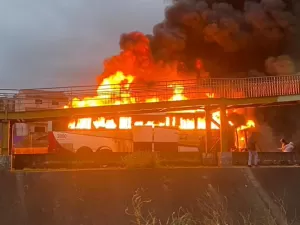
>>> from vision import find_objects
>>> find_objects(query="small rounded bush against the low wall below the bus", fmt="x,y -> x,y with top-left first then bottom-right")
123,151 -> 160,169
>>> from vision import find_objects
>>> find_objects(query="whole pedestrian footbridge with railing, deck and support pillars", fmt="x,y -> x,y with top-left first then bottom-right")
0,75 -> 300,165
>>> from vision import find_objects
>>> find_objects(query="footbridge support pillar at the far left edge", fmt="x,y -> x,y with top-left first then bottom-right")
0,121 -> 12,170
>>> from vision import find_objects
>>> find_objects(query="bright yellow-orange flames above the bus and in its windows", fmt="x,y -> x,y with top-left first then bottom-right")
65,72 -> 255,150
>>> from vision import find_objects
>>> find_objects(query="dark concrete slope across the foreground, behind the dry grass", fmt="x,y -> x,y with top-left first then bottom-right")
0,168 -> 300,225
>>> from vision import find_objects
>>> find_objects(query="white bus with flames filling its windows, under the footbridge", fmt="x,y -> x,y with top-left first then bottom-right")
44,110 -> 254,153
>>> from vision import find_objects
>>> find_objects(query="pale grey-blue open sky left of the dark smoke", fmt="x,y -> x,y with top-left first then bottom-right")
0,0 -> 165,88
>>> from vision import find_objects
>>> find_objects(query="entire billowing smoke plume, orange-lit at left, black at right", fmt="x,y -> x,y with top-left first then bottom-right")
99,0 -> 299,81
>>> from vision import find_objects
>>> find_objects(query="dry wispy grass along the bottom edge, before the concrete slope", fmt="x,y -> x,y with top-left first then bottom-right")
125,189 -> 295,225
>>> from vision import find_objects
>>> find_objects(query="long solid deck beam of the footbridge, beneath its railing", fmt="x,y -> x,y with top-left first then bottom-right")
0,95 -> 300,122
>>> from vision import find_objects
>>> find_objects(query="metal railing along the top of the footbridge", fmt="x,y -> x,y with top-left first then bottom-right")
0,75 -> 300,111
